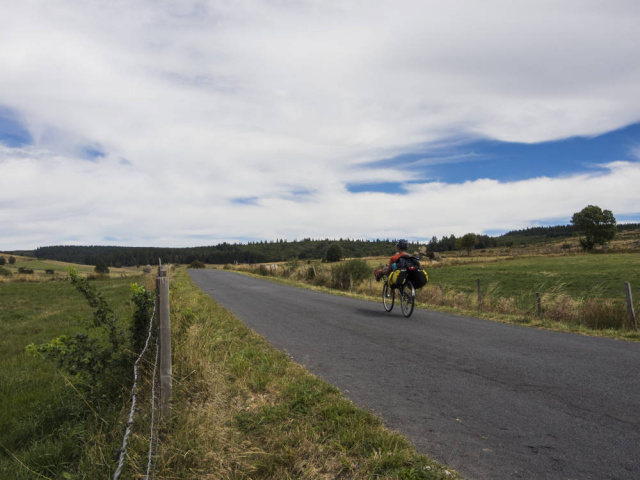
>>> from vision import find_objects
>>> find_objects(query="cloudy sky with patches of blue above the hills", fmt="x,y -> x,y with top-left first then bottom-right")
0,0 -> 640,251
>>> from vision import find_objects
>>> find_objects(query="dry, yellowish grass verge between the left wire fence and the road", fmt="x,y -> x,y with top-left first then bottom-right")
140,269 -> 459,480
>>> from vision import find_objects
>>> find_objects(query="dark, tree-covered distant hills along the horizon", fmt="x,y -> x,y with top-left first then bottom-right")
6,223 -> 640,267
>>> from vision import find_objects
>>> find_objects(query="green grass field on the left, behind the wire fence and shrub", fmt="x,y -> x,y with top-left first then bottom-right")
0,278 -> 139,480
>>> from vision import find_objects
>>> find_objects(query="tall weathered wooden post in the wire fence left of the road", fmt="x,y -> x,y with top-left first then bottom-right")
156,266 -> 172,418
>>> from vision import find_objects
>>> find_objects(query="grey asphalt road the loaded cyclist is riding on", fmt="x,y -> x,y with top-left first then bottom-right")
190,270 -> 640,480
